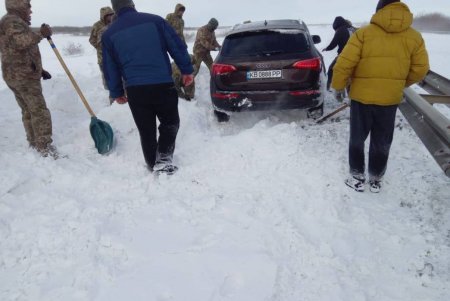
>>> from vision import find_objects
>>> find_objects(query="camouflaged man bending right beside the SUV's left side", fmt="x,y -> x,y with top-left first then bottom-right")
194,18 -> 221,75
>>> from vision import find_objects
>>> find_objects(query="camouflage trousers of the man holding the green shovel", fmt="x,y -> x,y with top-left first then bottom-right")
6,80 -> 52,152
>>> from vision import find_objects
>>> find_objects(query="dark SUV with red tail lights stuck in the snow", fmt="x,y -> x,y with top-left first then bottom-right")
210,20 -> 324,121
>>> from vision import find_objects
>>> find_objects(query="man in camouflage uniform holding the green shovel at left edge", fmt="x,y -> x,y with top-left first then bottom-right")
0,0 -> 57,158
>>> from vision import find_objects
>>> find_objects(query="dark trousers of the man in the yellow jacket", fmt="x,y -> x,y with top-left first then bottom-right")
349,100 -> 397,180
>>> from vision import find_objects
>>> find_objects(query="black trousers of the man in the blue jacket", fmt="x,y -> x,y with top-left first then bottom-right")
127,83 -> 180,169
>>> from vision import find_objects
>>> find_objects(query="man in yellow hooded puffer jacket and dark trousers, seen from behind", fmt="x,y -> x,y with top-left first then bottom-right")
332,0 -> 429,192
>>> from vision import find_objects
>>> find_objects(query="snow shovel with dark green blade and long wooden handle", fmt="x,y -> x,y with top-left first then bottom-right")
47,37 -> 114,155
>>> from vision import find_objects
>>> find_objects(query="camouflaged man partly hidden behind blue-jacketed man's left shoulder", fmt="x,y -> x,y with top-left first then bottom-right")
89,6 -> 114,90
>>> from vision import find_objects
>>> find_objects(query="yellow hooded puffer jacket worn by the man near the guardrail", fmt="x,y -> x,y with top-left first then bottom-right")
331,2 -> 429,106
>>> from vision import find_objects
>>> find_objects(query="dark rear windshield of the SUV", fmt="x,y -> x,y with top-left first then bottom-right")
221,30 -> 309,57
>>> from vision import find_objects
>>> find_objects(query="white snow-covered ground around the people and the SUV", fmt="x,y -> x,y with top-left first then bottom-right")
0,26 -> 450,301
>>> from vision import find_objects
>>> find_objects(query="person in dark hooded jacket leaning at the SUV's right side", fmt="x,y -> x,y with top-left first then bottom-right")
322,16 -> 355,90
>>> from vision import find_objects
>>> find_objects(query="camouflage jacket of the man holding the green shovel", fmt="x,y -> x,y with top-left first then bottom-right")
0,13 -> 43,81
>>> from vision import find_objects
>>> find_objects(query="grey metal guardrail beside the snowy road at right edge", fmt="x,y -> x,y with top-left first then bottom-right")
399,71 -> 450,177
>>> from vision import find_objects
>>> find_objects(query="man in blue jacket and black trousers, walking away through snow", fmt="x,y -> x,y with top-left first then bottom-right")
102,0 -> 194,174
